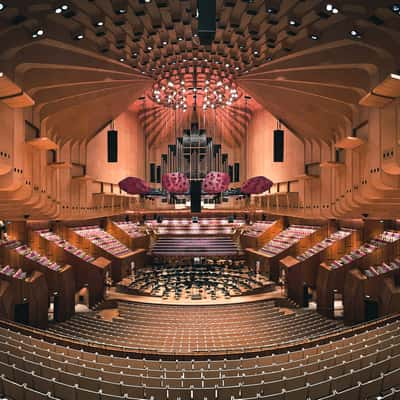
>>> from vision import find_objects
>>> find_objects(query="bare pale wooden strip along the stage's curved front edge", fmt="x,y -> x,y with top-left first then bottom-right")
106,287 -> 286,306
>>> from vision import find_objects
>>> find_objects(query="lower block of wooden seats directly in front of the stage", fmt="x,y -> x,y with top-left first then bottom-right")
50,301 -> 343,354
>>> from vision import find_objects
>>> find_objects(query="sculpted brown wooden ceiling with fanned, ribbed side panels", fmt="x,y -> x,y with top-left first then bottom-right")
0,0 -> 400,142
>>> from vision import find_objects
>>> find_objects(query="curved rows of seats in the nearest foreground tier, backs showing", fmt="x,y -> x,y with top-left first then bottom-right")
0,318 -> 400,400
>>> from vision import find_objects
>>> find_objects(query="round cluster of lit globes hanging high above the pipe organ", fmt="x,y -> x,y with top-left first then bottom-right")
151,67 -> 242,111
